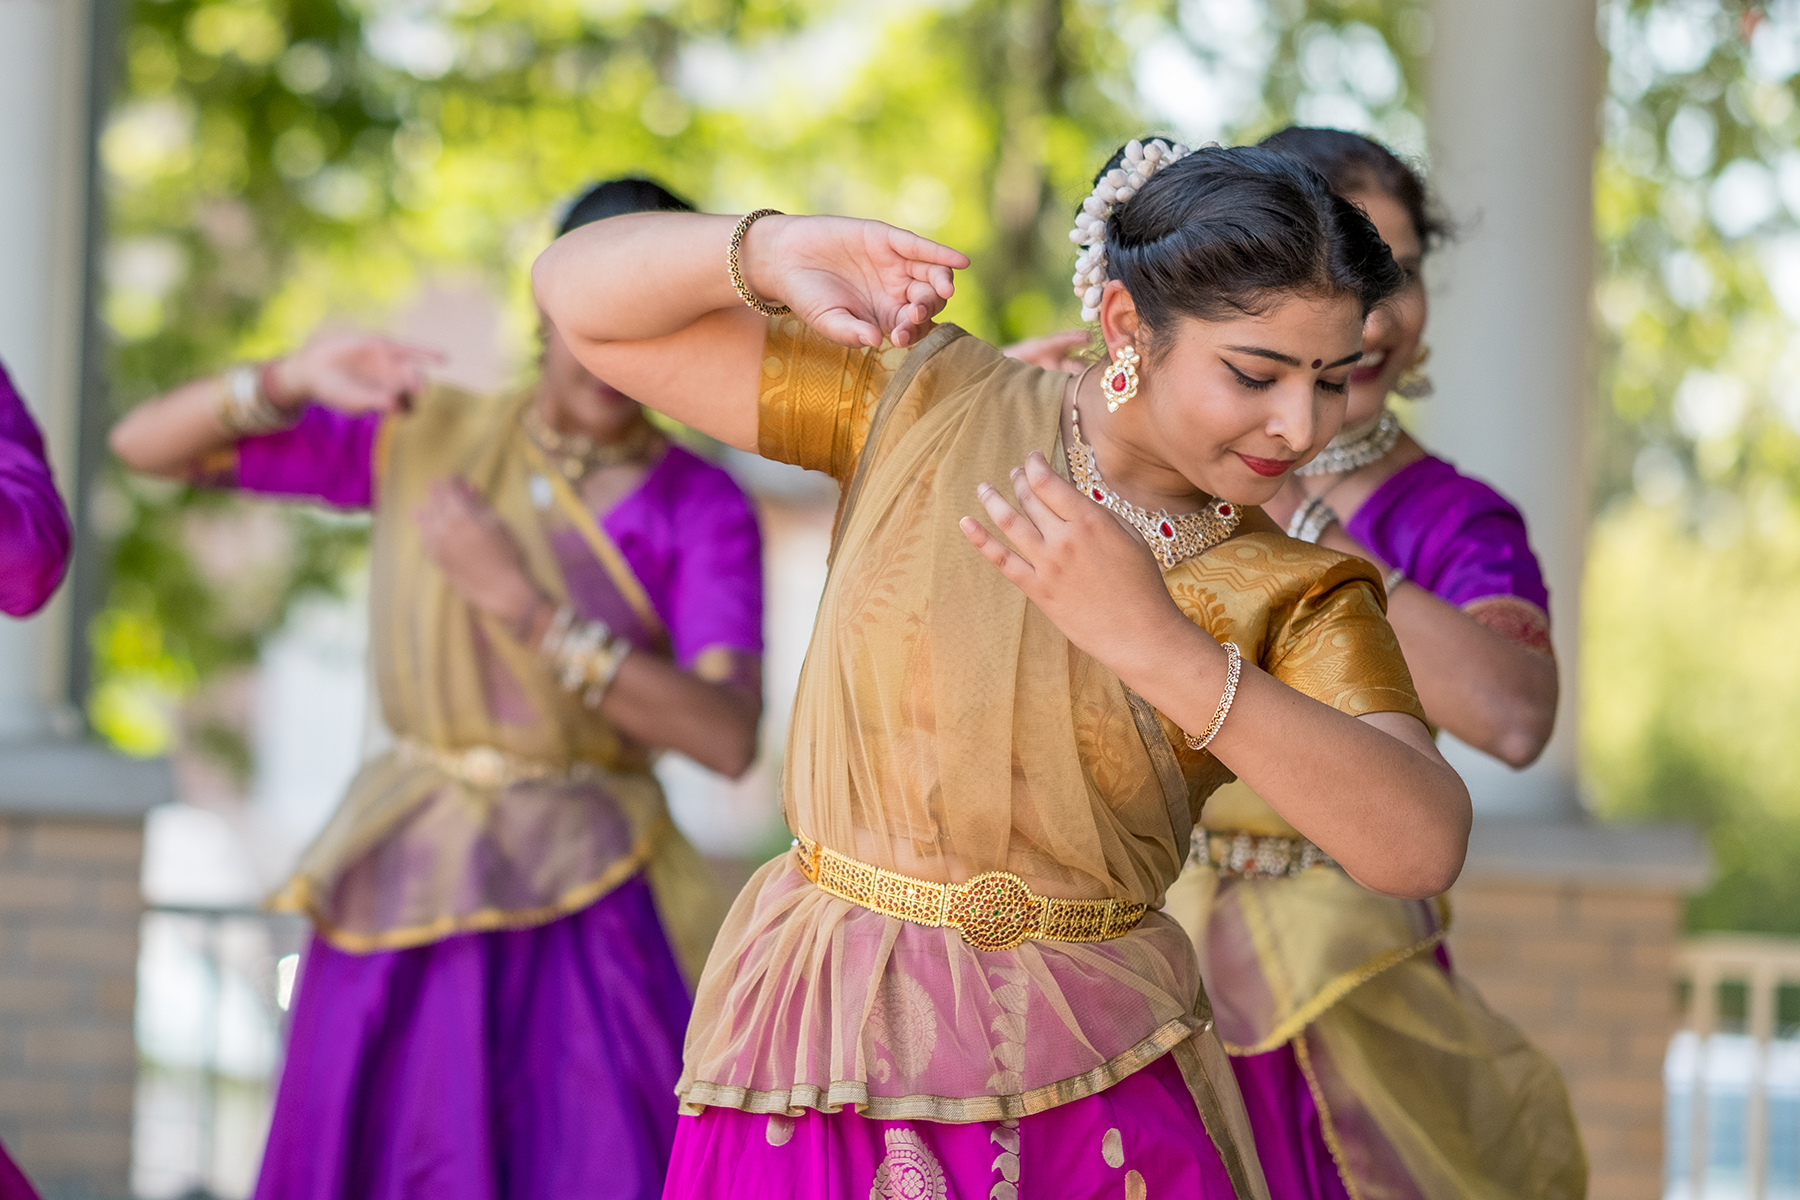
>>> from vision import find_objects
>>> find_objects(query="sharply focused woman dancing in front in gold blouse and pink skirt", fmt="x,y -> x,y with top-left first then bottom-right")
535,140 -> 1469,1200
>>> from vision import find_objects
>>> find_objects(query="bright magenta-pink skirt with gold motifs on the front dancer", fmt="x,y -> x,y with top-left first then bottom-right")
662,1054 -> 1231,1200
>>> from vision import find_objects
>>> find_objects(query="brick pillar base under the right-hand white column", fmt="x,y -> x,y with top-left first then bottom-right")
1451,878 -> 1681,1200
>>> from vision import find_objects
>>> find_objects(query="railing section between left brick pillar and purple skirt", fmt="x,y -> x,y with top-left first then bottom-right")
131,905 -> 306,1200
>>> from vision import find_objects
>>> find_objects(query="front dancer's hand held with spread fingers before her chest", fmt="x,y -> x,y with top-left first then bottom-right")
959,452 -> 1195,675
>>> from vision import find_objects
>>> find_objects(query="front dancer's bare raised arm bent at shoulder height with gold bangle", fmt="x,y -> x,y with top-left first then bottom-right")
531,212 -> 968,452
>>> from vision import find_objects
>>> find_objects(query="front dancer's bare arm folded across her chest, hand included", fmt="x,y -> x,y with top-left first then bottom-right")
963,453 -> 1472,896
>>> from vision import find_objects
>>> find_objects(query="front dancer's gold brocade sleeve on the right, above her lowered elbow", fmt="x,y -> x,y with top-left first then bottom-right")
1267,558 -> 1426,721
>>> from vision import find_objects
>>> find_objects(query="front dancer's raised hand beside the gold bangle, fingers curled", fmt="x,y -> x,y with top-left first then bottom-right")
740,216 -> 968,345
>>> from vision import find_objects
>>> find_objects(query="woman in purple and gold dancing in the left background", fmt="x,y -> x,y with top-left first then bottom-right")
113,180 -> 761,1200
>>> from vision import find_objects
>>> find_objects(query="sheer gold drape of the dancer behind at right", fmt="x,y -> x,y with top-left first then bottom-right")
1165,783 -> 1588,1200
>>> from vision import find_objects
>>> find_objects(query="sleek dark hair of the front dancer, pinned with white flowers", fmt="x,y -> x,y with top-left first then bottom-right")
1094,139 -> 1404,347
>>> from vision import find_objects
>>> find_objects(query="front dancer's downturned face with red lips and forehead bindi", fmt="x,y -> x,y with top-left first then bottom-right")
1102,284 -> 1363,504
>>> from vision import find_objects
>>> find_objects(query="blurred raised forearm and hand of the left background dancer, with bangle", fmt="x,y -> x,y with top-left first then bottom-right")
108,335 -> 439,479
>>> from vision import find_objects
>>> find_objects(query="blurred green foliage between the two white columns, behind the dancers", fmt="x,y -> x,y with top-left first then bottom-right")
102,0 -> 1418,752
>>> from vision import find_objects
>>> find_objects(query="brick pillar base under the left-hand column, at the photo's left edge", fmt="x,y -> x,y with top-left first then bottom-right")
0,815 -> 144,1200
